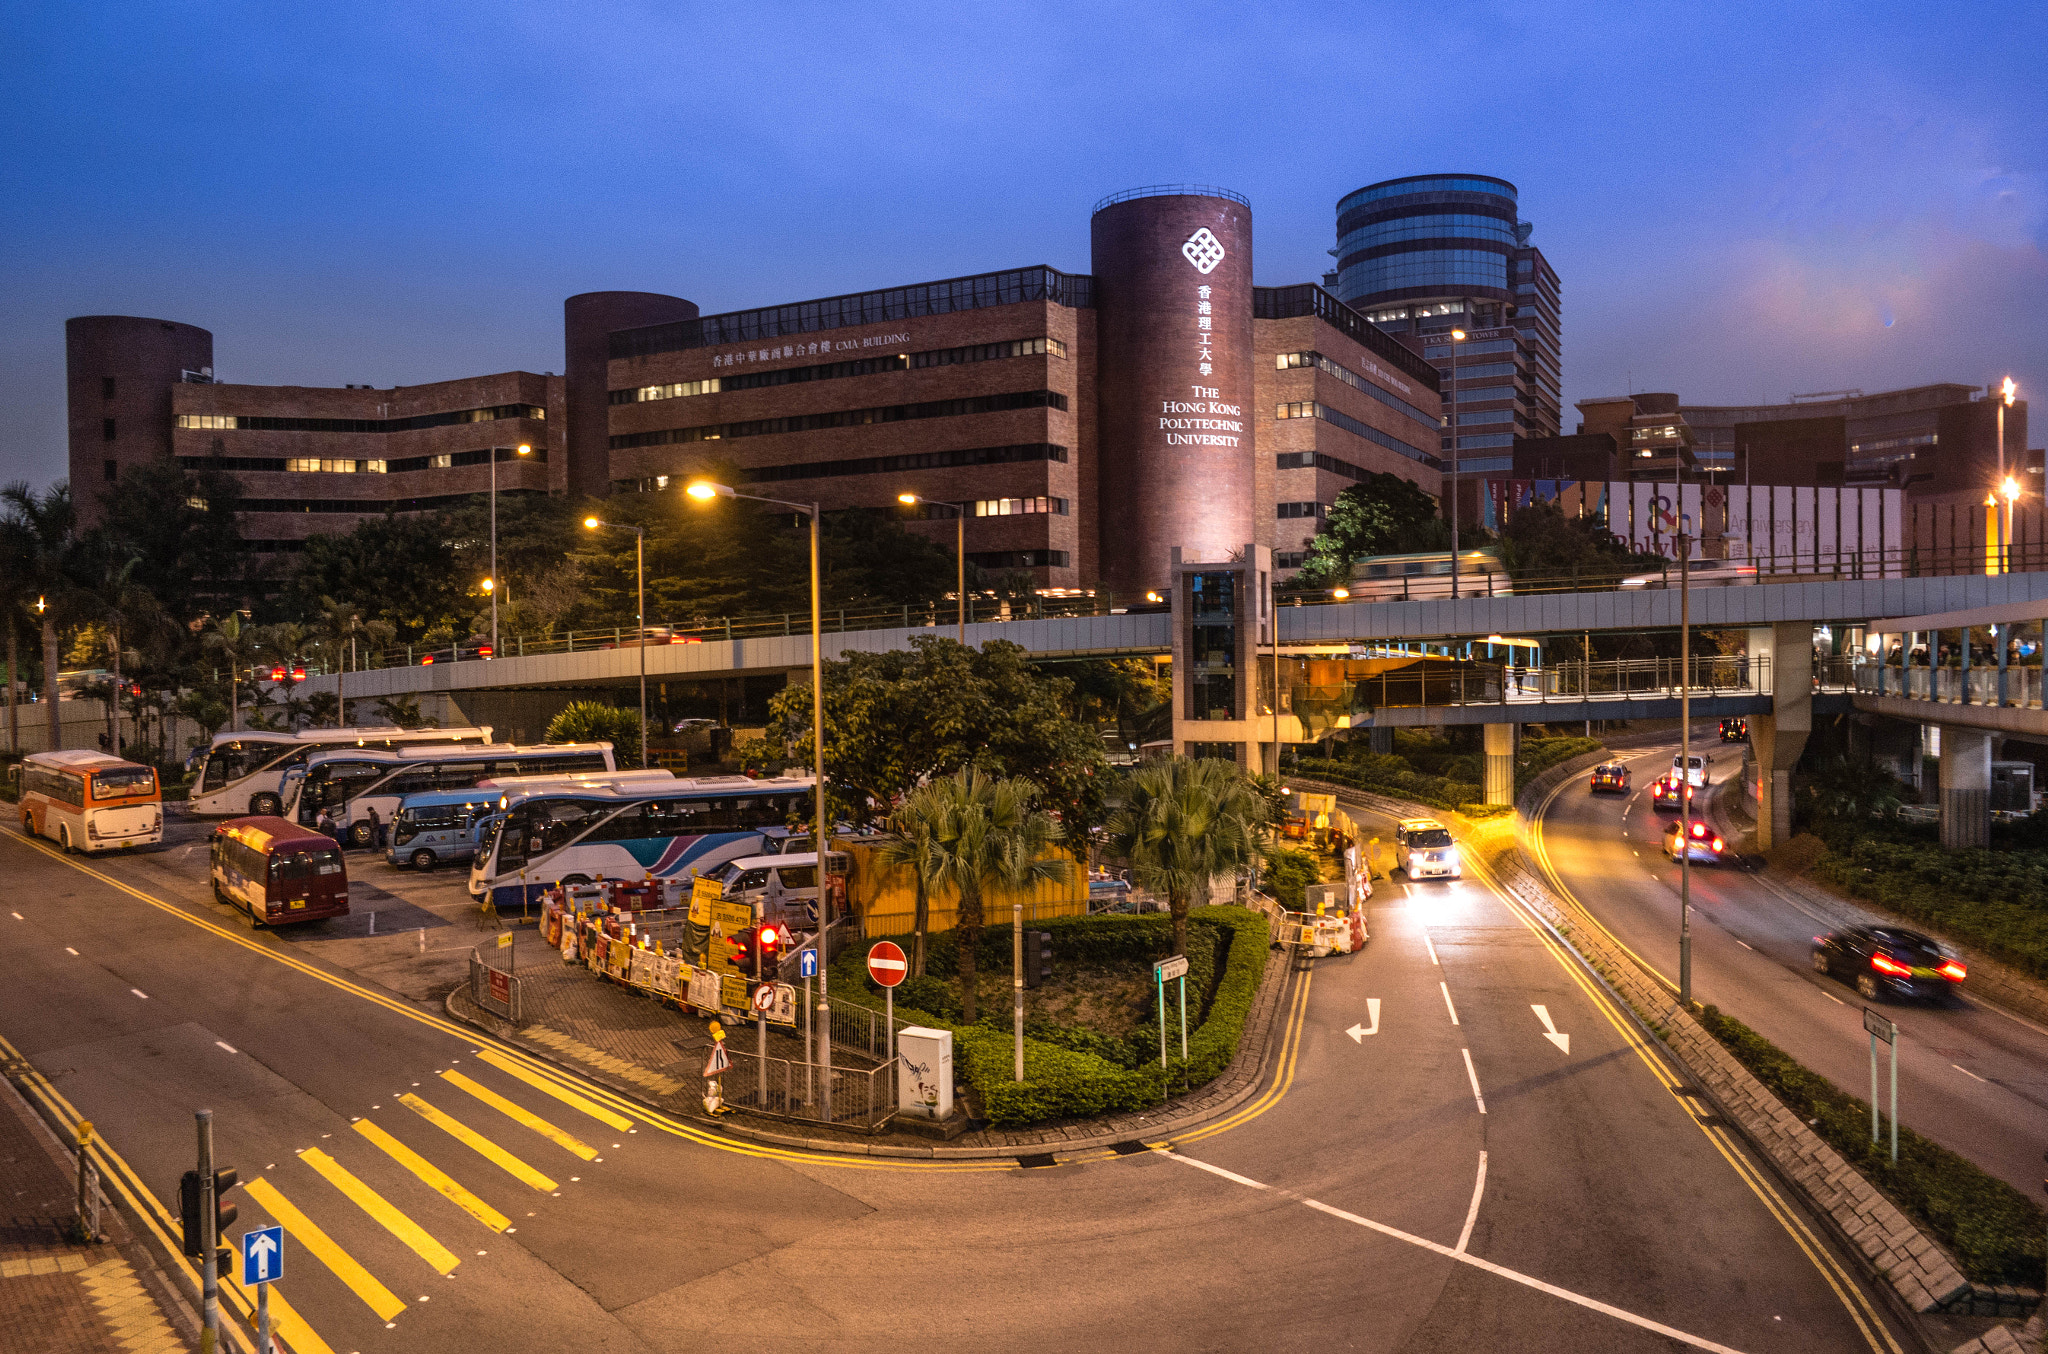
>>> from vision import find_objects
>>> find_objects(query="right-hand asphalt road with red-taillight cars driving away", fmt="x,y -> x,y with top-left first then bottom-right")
1538,725 -> 2048,1196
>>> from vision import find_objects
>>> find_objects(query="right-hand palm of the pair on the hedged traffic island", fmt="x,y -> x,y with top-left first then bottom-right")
1110,758 -> 1268,955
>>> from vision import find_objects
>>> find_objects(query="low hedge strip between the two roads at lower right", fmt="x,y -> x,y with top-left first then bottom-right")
1700,1006 -> 2048,1286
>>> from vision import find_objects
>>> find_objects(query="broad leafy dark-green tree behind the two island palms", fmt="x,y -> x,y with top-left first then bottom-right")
770,635 -> 1108,842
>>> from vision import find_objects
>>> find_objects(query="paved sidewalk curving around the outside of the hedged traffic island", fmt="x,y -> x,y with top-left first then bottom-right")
446,934 -> 1290,1157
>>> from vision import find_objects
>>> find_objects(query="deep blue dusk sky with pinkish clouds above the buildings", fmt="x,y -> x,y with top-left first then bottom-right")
0,0 -> 2048,483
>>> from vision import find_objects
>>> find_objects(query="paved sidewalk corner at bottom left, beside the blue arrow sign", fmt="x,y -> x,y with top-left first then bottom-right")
0,1080 -> 193,1354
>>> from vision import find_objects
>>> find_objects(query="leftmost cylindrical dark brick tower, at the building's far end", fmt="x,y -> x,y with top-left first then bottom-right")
63,315 -> 213,522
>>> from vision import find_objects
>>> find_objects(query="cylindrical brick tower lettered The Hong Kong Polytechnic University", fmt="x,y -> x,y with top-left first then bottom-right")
1090,184 -> 1255,598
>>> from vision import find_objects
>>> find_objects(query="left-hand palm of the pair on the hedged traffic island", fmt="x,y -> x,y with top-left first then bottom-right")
926,766 -> 1073,1024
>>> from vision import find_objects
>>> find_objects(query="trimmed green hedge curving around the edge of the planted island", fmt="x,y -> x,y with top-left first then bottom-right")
831,907 -> 1266,1129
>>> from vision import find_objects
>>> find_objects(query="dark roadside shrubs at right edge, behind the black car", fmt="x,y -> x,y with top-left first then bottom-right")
1812,823 -> 2048,979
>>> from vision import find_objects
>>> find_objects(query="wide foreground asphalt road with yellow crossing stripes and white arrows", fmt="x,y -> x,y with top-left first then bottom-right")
0,815 -> 1901,1354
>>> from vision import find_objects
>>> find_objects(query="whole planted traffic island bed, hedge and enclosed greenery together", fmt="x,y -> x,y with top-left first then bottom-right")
831,905 -> 1268,1129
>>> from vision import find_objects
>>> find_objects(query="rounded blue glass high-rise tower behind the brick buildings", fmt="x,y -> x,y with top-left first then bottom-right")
1323,174 -> 1563,475
